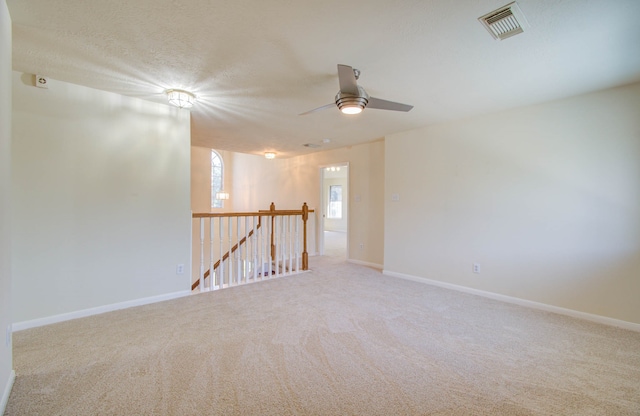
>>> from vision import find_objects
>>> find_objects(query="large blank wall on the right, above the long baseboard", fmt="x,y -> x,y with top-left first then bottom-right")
384,84 -> 640,323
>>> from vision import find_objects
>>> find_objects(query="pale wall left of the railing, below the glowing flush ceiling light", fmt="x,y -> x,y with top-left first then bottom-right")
12,72 -> 191,322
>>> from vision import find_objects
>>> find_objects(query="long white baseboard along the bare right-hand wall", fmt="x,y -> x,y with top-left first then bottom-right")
382,270 -> 640,332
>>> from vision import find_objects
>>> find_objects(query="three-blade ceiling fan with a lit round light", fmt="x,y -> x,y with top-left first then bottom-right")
298,64 -> 413,116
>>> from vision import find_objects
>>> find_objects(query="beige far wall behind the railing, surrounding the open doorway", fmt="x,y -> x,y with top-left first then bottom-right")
192,141 -> 384,266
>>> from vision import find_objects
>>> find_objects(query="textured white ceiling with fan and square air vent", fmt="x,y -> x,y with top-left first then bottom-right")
7,0 -> 640,157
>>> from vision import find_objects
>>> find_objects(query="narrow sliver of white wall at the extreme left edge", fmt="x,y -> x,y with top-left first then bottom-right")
0,0 -> 13,413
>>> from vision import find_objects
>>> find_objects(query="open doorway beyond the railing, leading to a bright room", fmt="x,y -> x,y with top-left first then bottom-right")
320,163 -> 349,259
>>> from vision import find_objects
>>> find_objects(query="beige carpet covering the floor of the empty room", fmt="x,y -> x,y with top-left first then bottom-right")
5,257 -> 640,415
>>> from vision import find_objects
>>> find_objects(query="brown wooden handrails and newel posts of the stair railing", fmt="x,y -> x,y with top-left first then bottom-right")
191,202 -> 315,290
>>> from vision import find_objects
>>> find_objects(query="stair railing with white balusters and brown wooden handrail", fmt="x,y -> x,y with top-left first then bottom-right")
191,202 -> 314,291
